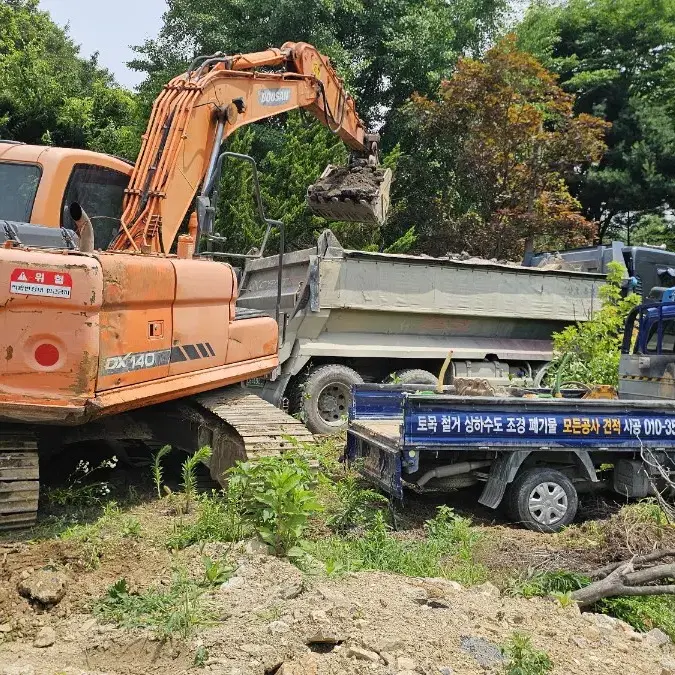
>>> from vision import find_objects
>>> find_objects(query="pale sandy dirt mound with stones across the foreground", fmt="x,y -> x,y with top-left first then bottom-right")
0,544 -> 675,675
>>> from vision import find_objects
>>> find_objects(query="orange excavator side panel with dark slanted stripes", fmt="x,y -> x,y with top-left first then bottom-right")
169,258 -> 236,375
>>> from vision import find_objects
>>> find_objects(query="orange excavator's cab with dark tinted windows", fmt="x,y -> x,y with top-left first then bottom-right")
0,141 -> 133,249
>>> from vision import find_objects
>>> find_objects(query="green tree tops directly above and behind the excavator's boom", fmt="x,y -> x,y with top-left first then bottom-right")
132,0 -> 507,136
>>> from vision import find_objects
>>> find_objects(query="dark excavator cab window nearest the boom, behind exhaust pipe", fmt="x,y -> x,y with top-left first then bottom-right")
61,164 -> 129,250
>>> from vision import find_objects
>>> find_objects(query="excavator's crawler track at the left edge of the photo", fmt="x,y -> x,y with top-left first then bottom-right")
0,431 -> 40,530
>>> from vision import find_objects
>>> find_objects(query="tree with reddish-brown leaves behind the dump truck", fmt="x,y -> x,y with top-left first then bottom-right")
396,36 -> 606,258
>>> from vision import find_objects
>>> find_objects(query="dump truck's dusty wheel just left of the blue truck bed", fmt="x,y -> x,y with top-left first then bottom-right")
300,364 -> 363,435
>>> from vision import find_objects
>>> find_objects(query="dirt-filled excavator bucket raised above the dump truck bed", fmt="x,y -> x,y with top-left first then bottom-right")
307,162 -> 392,225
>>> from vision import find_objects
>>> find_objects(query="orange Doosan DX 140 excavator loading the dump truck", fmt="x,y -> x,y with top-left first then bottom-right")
0,43 -> 391,529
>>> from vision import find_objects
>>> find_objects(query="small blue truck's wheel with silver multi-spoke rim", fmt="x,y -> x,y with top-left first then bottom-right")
506,468 -> 579,532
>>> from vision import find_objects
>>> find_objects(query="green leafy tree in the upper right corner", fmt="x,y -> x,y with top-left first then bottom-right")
517,0 -> 675,239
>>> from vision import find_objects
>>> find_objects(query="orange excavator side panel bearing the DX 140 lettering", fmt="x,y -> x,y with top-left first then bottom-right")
96,253 -> 176,391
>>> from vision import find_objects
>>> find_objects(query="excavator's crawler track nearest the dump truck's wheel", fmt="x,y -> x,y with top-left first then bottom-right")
195,388 -> 314,459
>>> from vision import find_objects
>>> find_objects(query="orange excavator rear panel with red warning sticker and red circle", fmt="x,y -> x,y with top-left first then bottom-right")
0,249 -> 103,406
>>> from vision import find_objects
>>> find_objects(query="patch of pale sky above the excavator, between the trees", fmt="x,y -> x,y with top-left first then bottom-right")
40,0 -> 166,88
